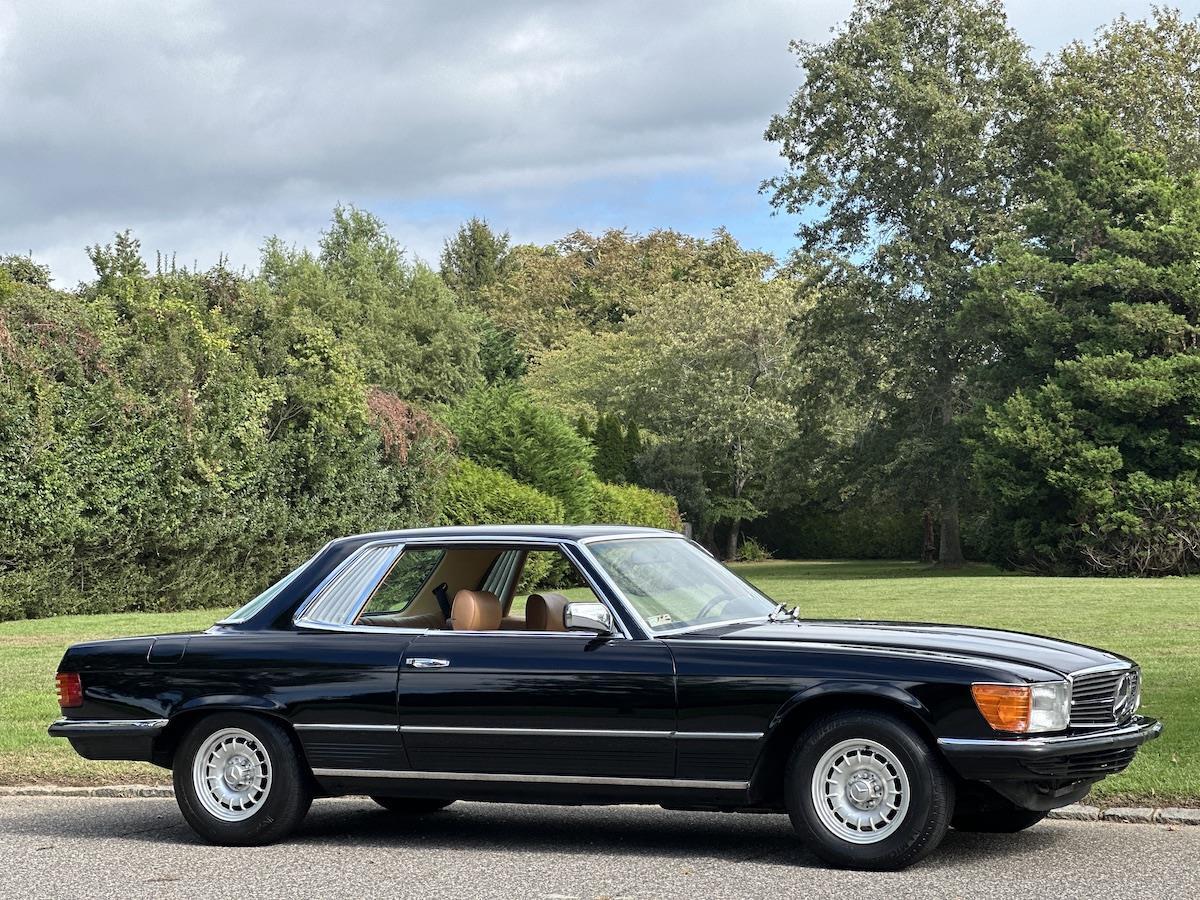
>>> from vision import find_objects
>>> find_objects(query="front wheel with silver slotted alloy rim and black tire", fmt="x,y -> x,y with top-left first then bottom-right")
785,712 -> 954,870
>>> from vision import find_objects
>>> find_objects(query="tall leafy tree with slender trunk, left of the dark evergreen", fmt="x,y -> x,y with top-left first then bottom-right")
764,0 -> 1043,565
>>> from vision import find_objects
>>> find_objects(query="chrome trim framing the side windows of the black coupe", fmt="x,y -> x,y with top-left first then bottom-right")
292,533 -> 633,640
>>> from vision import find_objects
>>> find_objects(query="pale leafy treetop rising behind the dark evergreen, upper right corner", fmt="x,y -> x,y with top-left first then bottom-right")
1050,6 -> 1200,174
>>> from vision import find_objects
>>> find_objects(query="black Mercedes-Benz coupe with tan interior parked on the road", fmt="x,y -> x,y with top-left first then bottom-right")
50,526 -> 1162,869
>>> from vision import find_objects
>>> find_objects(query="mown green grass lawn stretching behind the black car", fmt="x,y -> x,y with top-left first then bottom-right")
0,560 -> 1200,806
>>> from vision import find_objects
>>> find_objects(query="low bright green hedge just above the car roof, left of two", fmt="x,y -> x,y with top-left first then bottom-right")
442,460 -> 563,524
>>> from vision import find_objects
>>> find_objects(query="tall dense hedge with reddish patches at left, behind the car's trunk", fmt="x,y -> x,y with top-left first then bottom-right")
0,250 -> 451,619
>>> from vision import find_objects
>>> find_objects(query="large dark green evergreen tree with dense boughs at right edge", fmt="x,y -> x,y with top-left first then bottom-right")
968,113 -> 1200,575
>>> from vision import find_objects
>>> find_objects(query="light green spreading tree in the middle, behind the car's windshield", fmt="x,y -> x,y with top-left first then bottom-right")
527,278 -> 800,557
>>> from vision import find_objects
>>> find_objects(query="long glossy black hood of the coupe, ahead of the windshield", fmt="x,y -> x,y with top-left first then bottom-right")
690,619 -> 1130,674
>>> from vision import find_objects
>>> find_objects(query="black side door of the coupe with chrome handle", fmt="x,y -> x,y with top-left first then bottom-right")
397,542 -> 676,781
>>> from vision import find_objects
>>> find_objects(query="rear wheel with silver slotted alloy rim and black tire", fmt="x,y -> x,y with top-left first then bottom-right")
173,713 -> 312,846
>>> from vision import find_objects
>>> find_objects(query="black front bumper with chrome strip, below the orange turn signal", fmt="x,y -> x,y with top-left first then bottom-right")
937,715 -> 1163,782
